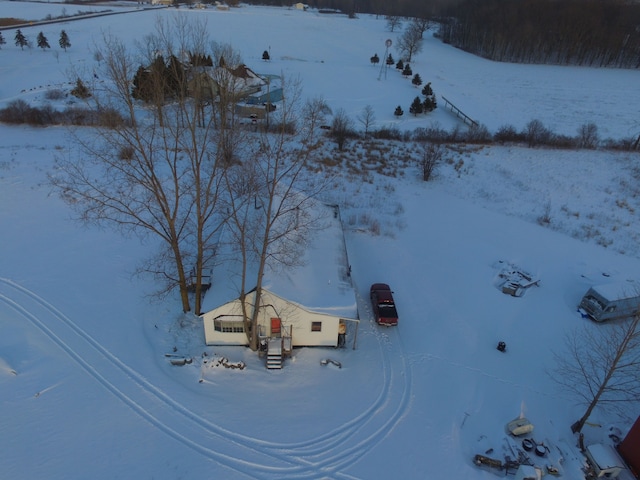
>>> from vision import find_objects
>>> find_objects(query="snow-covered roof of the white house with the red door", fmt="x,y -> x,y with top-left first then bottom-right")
203,204 -> 358,318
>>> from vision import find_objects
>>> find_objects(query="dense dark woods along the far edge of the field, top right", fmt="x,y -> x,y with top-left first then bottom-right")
439,0 -> 640,68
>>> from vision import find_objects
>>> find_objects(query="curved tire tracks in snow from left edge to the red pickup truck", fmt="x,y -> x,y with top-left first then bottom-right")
0,278 -> 411,479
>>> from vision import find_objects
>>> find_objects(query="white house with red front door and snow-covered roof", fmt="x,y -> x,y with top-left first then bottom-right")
201,204 -> 358,347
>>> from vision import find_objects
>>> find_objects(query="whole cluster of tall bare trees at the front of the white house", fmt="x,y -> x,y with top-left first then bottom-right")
50,17 -> 326,349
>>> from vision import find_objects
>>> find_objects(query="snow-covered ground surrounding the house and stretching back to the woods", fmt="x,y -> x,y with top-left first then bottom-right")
0,1 -> 640,480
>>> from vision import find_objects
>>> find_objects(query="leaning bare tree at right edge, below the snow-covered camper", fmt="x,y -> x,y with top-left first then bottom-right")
550,314 -> 640,433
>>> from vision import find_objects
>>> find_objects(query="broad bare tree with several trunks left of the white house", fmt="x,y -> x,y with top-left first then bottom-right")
50,17 -> 230,313
